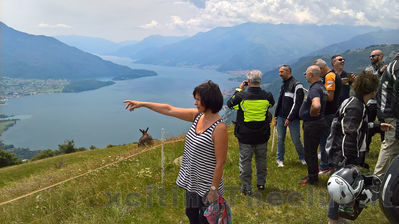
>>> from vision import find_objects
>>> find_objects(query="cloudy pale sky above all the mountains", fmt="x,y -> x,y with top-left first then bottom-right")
0,0 -> 399,42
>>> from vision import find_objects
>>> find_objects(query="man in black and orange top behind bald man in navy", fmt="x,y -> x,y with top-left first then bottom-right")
313,58 -> 342,174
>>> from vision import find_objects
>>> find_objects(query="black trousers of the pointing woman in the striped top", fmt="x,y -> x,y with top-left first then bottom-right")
186,191 -> 208,224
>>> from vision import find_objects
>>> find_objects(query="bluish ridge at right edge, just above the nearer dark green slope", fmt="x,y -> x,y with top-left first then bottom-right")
309,30 -> 399,56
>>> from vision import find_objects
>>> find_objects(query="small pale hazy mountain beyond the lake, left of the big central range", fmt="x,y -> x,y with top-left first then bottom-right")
108,35 -> 187,59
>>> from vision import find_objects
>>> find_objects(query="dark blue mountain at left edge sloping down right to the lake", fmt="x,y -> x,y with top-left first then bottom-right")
0,22 -> 155,79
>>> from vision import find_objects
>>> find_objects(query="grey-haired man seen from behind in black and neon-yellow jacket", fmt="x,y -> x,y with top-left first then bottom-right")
227,70 -> 274,195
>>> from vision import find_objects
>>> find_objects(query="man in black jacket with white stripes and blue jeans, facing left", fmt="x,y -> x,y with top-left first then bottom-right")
274,65 -> 306,167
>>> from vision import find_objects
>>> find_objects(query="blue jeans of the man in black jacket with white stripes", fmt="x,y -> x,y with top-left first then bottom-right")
277,117 -> 305,161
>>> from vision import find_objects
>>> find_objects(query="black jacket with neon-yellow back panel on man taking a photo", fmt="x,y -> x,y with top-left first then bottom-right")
227,87 -> 274,144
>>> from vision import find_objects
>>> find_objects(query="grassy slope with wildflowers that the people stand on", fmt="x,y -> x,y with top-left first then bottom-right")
0,127 -> 387,223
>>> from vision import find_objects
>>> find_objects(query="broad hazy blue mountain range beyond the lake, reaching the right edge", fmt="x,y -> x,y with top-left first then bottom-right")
59,23 -> 399,72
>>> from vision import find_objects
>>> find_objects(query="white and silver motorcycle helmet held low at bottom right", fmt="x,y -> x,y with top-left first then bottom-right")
327,165 -> 364,205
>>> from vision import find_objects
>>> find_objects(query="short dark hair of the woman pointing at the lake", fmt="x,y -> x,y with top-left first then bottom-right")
193,80 -> 223,113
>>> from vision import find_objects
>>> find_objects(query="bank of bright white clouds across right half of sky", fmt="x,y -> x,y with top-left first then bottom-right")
180,0 -> 399,32
